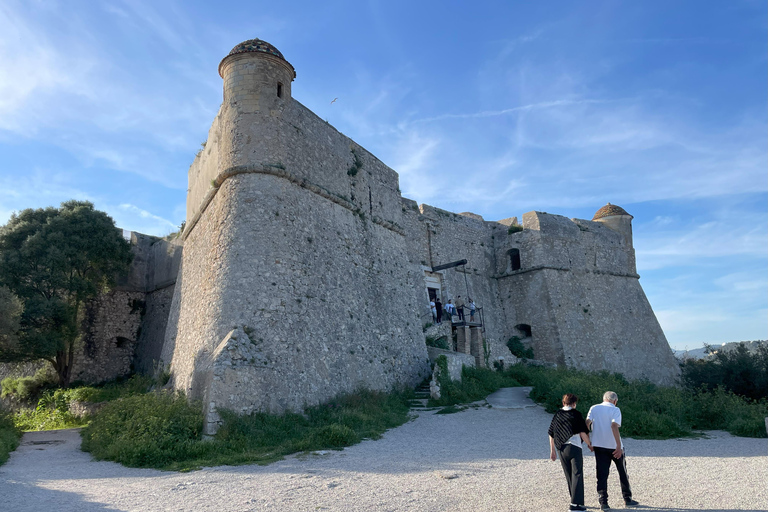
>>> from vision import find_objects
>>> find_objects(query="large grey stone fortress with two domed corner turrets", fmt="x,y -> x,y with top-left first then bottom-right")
21,39 -> 679,433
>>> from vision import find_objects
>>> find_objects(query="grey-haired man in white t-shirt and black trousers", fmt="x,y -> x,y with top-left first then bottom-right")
587,391 -> 639,510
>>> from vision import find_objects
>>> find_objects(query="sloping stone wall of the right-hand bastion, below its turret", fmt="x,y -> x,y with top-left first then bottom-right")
496,212 -> 678,384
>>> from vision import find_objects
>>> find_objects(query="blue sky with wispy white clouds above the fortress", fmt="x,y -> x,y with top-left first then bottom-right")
0,0 -> 768,349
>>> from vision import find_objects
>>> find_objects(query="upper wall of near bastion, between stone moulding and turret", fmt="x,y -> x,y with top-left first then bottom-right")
185,98 -> 402,243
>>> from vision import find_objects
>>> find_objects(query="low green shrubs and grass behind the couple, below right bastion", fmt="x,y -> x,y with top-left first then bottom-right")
505,364 -> 768,439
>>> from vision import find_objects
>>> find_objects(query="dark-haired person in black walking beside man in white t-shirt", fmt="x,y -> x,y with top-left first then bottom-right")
549,393 -> 594,510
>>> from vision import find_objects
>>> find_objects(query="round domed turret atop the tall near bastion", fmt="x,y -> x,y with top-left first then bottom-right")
219,39 -> 296,114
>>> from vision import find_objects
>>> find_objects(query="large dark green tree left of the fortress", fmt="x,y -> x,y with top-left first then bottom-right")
0,200 -> 131,386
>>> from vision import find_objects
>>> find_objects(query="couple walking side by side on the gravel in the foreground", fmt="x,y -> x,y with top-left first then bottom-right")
549,391 -> 638,510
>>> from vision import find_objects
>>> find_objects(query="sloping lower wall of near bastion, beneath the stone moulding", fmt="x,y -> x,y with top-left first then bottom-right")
194,174 -> 429,426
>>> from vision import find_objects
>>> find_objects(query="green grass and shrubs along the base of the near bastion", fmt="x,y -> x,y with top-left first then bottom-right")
82,390 -> 413,471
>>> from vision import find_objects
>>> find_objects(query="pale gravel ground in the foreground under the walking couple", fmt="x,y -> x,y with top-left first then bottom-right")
0,390 -> 768,512
